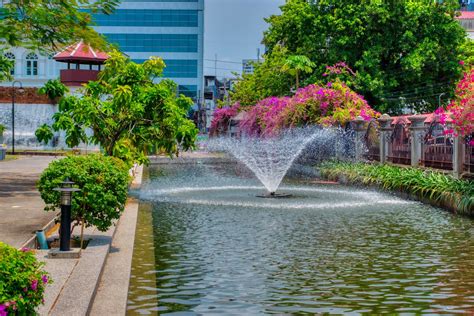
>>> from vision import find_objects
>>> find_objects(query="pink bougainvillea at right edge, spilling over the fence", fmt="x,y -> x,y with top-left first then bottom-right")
435,68 -> 474,146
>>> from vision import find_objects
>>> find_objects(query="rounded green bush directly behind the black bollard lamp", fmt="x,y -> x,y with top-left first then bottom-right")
38,154 -> 129,231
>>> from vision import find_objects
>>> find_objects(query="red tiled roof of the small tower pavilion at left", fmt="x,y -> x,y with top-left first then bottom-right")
53,41 -> 109,64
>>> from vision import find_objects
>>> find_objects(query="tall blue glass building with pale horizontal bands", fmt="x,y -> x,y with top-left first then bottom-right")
93,0 -> 204,98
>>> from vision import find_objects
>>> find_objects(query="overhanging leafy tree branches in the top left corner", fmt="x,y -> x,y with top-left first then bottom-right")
0,0 -> 120,81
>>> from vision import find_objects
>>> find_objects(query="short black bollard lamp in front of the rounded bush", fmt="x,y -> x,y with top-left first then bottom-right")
53,178 -> 81,251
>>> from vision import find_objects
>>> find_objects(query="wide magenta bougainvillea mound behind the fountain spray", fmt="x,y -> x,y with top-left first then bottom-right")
240,80 -> 380,135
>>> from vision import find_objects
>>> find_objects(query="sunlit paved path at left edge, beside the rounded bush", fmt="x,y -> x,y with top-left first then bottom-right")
0,156 -> 56,247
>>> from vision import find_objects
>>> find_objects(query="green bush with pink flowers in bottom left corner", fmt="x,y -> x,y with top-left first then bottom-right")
0,242 -> 51,316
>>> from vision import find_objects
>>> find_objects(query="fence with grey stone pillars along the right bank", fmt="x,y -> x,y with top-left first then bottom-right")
350,114 -> 474,177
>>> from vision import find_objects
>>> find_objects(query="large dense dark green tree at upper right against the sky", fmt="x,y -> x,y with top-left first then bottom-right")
264,0 -> 474,113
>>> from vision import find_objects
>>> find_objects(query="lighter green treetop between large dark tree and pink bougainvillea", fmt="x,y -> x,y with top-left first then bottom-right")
231,46 -> 293,106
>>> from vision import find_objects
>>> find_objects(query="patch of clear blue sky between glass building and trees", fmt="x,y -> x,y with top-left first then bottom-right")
204,0 -> 285,78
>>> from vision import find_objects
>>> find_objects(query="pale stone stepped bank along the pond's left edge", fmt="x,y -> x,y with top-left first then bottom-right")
37,167 -> 143,315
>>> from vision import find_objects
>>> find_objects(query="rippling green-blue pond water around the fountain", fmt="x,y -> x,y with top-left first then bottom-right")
128,162 -> 474,315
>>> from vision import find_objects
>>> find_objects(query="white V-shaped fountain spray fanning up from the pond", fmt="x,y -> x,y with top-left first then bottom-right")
207,127 -> 348,196
